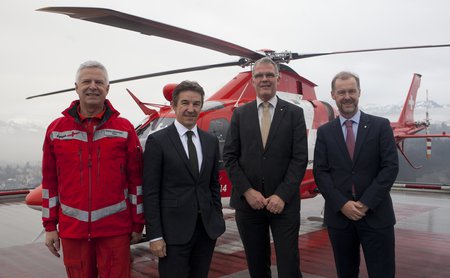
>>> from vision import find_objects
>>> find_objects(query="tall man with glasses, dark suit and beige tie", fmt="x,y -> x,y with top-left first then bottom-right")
224,58 -> 308,278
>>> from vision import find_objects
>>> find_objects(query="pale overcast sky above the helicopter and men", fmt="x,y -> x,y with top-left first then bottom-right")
0,0 -> 450,125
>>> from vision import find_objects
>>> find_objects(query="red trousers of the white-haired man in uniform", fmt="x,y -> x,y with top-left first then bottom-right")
61,235 -> 130,278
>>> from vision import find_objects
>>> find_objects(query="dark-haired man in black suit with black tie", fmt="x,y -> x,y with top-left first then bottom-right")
143,81 -> 225,278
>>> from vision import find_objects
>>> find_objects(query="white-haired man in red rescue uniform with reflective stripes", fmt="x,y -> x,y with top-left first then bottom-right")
42,61 -> 144,278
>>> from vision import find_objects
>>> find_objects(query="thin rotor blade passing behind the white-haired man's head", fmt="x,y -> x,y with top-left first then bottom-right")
26,58 -> 247,99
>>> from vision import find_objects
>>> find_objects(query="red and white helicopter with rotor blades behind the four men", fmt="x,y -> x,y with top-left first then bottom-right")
26,7 -> 450,209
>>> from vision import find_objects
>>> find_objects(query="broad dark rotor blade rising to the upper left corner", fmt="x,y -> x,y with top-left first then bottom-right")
38,7 -> 264,61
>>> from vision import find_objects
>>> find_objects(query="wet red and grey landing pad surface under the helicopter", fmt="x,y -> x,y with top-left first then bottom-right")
0,191 -> 450,278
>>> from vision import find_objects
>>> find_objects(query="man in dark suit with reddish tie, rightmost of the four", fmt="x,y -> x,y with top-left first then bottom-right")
314,72 -> 398,278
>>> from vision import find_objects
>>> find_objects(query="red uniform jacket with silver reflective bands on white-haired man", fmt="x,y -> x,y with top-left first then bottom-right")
42,100 -> 144,238
